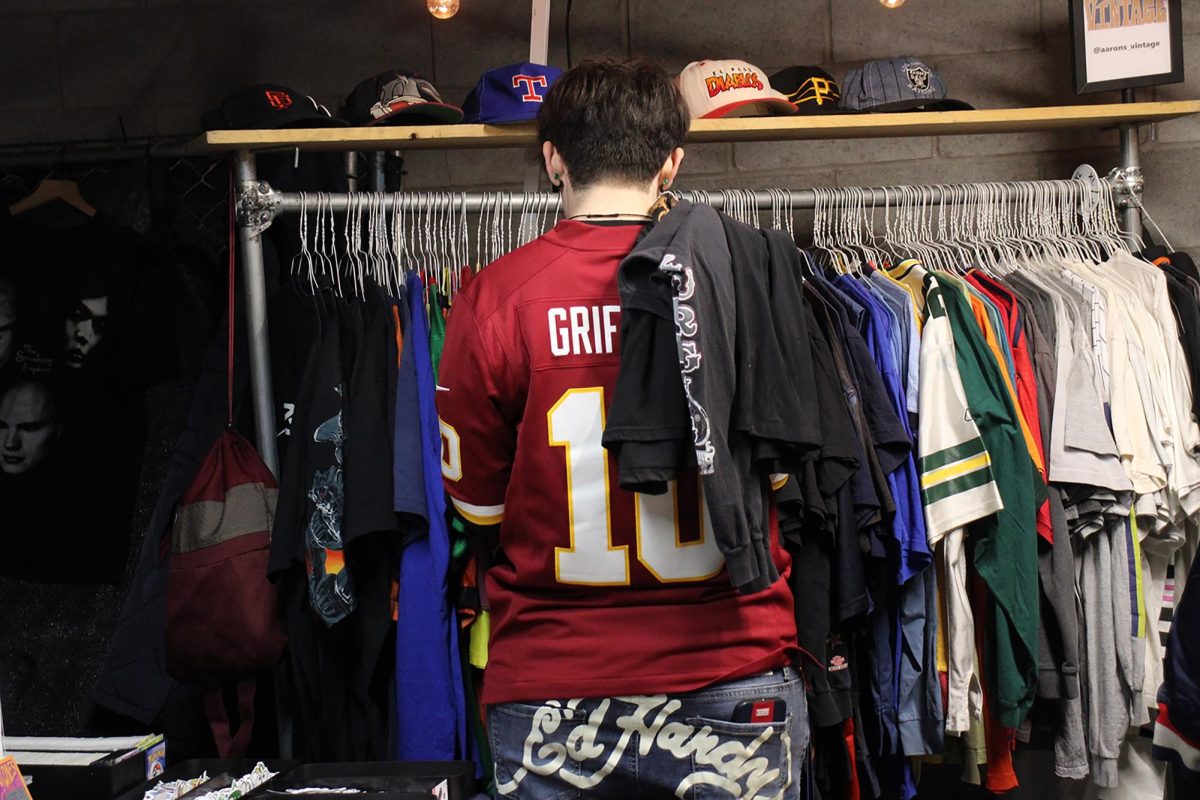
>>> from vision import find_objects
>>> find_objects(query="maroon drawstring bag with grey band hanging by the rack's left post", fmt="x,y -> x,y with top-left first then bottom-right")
163,181 -> 287,758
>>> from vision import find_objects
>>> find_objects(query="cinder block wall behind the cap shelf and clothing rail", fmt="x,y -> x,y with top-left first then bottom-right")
0,0 -> 1200,245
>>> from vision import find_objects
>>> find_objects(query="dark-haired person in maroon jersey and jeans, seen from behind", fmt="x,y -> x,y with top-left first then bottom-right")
437,60 -> 808,800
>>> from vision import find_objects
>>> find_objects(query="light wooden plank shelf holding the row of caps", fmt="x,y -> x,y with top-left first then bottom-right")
188,100 -> 1200,154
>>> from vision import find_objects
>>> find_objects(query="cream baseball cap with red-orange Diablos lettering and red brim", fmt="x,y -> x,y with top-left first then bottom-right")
677,59 -> 796,119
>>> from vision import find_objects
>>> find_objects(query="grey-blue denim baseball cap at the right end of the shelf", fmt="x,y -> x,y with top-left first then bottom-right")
841,55 -> 973,112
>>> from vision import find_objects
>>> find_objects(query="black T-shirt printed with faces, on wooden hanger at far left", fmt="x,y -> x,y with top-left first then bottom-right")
0,211 -> 178,583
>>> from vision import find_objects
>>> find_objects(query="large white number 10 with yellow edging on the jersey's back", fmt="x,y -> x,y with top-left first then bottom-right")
546,386 -> 725,587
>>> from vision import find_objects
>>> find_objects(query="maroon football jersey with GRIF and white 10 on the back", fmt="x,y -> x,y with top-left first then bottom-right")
437,221 -> 796,703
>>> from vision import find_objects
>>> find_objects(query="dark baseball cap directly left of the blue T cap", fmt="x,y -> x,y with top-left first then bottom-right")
337,70 -> 462,125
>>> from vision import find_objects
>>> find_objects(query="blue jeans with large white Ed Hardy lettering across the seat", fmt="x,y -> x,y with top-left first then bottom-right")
487,667 -> 809,800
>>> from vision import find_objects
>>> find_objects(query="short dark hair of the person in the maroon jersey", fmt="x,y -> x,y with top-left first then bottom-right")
538,59 -> 691,188
